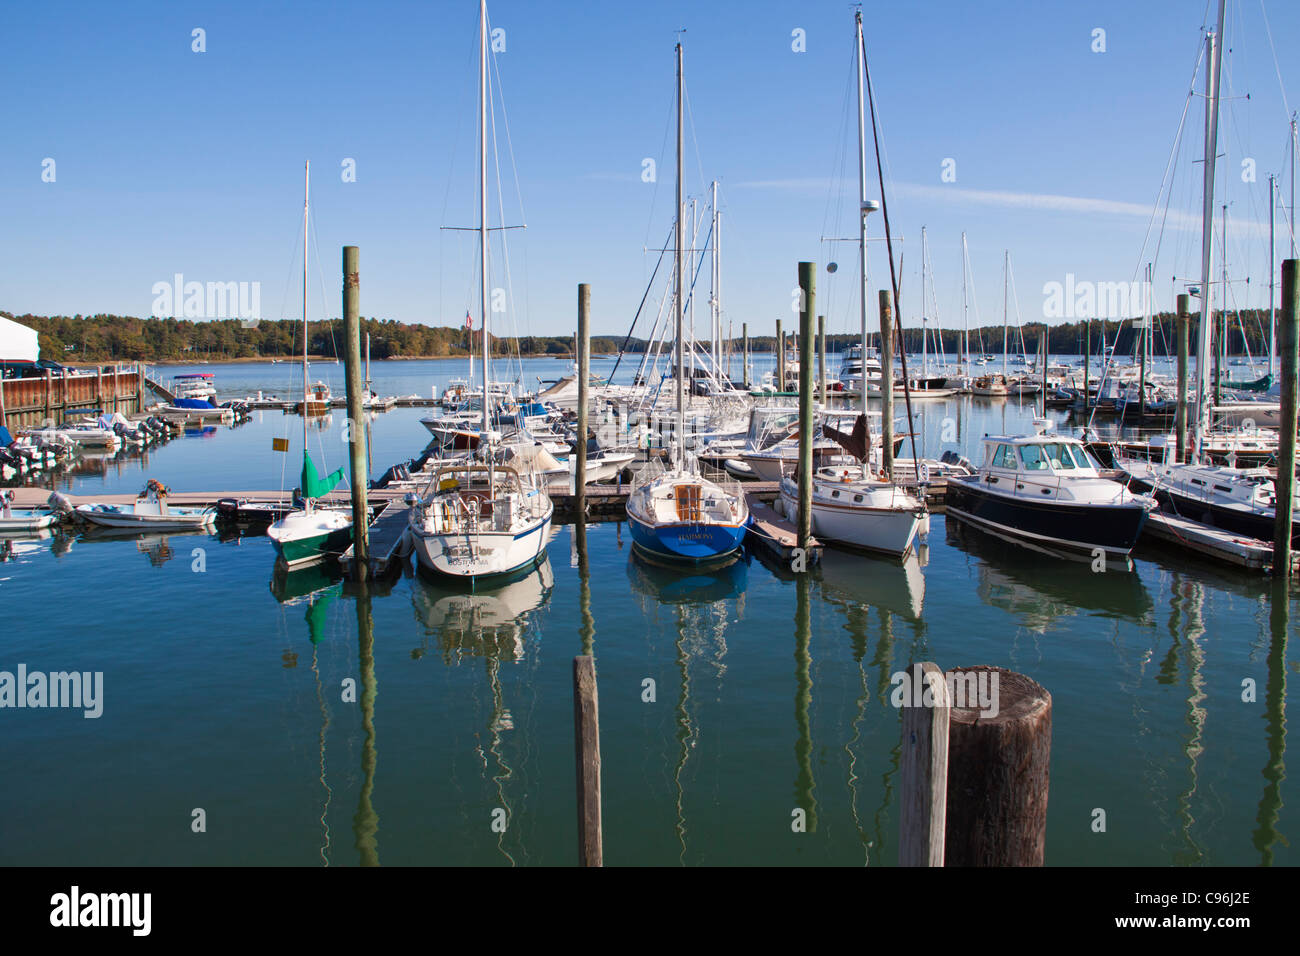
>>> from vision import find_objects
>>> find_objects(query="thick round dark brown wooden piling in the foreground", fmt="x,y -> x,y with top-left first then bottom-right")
944,666 -> 1052,866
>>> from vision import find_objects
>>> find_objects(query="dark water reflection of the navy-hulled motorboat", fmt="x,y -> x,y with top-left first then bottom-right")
945,522 -> 1154,633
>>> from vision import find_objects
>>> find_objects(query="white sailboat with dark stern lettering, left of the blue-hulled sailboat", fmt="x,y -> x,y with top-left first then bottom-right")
408,0 -> 555,580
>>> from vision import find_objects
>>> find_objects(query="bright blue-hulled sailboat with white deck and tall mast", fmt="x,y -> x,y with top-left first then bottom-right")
627,43 -> 749,564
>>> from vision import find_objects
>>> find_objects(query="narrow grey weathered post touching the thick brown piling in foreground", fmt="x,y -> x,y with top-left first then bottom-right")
898,661 -> 953,866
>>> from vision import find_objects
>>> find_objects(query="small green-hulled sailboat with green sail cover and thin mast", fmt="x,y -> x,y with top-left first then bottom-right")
267,163 -> 352,570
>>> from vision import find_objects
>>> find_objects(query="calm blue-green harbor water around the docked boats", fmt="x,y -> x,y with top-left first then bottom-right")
0,360 -> 1300,866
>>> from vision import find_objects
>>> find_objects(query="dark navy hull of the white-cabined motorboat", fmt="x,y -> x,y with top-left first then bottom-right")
946,476 -> 1148,558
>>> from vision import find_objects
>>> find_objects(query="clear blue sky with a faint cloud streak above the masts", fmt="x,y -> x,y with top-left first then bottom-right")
0,0 -> 1300,337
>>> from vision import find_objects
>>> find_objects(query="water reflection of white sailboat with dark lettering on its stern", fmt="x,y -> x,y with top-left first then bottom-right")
411,551 -> 555,866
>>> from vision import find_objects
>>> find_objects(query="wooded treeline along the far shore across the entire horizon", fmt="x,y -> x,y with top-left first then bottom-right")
0,310 -> 1269,362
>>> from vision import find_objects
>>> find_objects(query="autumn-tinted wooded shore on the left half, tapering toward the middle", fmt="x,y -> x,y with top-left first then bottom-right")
0,312 -> 645,362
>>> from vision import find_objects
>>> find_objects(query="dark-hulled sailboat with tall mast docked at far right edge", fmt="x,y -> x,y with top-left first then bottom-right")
1117,0 -> 1300,544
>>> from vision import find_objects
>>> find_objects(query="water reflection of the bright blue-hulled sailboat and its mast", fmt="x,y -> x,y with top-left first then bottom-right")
628,549 -> 749,864
